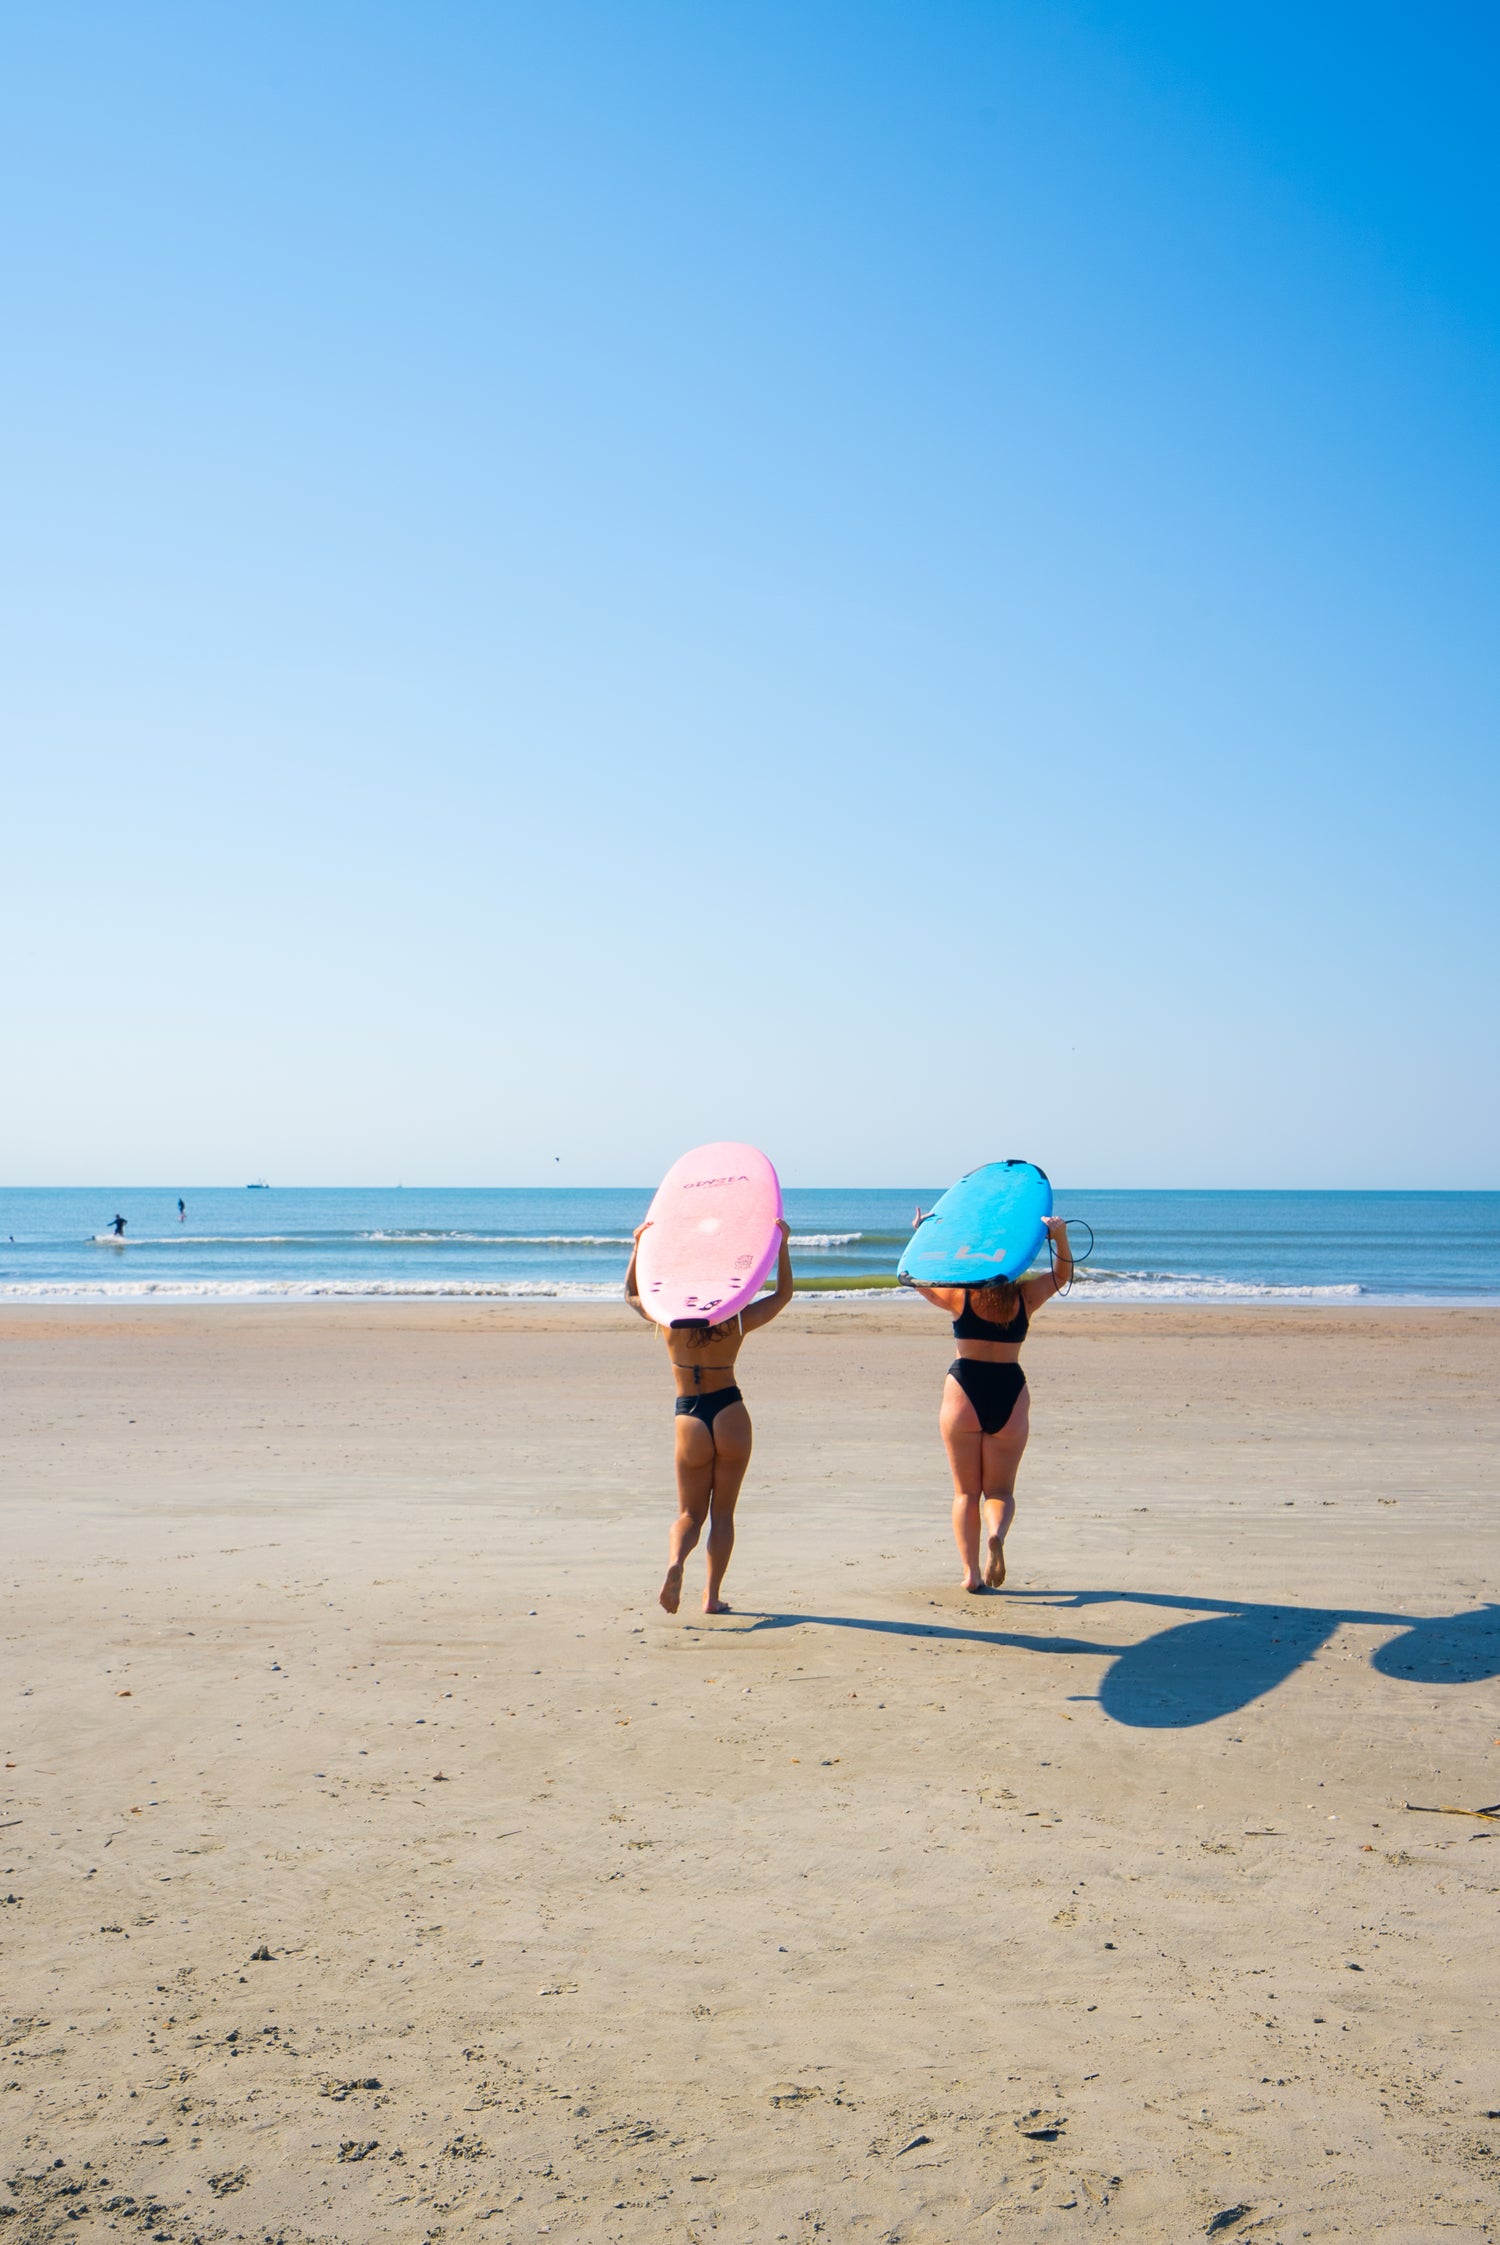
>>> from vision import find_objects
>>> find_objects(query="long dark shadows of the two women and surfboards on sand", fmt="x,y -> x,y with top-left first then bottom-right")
709,1589 -> 1500,1731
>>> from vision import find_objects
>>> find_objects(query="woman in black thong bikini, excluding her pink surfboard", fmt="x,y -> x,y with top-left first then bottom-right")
624,1219 -> 793,1614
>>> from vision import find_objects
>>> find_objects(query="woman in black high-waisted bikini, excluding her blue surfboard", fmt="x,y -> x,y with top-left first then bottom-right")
916,1210 -> 1073,1592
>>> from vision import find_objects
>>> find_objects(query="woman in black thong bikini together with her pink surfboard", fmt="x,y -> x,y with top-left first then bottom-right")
624,1143 -> 793,1614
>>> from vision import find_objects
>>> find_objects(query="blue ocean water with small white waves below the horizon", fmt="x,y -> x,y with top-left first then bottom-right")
0,1183 -> 1500,1302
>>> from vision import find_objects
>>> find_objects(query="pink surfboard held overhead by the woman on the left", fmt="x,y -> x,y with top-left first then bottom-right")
635,1140 -> 781,1325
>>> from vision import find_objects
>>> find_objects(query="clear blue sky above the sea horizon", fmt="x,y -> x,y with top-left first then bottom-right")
0,0 -> 1500,1185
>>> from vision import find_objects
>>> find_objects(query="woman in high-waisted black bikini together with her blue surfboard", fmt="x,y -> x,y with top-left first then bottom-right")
900,1161 -> 1073,1592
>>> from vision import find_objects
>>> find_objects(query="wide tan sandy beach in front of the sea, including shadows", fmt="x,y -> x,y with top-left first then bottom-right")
0,1302 -> 1500,2245
